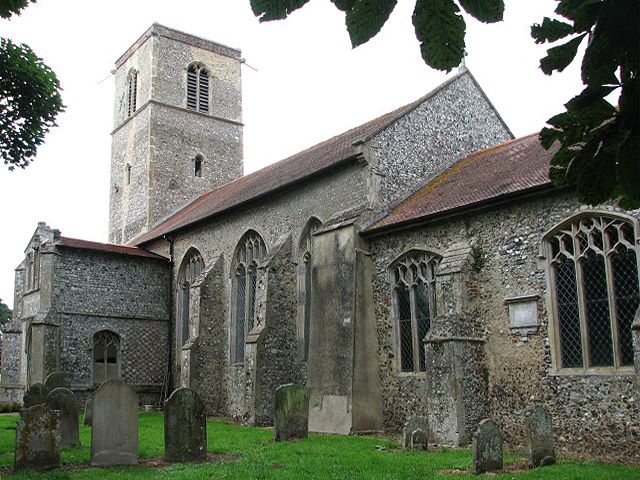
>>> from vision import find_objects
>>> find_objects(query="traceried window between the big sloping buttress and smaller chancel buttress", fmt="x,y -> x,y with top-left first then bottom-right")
389,250 -> 440,372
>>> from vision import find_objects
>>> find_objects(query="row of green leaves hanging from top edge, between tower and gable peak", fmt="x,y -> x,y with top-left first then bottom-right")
250,0 -> 504,72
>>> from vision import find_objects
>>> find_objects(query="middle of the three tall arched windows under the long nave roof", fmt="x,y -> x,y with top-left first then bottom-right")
232,231 -> 267,363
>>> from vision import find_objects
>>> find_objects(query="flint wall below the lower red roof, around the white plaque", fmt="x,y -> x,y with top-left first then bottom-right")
372,188 -> 640,458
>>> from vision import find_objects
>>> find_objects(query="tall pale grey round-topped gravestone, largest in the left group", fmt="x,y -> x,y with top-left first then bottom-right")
91,379 -> 138,467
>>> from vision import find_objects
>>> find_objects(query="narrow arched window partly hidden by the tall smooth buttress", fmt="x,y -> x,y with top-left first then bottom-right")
298,217 -> 322,360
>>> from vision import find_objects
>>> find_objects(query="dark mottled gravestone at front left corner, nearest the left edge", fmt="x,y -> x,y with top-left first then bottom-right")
13,404 -> 60,471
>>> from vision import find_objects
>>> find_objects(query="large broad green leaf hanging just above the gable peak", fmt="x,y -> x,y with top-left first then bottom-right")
412,0 -> 466,72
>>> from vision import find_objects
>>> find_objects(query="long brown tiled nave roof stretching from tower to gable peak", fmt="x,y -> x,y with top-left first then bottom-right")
129,70 -> 471,245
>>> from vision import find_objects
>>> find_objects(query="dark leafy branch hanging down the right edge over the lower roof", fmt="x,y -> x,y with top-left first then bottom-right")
531,0 -> 640,208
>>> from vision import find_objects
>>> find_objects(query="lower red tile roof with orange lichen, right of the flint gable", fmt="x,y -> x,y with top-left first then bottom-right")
366,133 -> 554,233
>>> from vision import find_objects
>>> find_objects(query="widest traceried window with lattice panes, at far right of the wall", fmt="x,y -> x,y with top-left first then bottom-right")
546,215 -> 640,370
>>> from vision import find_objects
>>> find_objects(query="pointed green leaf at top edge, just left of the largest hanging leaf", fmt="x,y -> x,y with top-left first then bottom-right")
346,0 -> 398,48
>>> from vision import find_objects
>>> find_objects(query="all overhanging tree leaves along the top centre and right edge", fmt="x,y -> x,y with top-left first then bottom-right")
250,0 -> 640,208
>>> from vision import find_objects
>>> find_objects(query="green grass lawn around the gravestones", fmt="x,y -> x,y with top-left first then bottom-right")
0,413 -> 640,480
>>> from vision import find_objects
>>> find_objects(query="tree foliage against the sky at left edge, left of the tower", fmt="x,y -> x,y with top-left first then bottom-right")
0,0 -> 64,170
